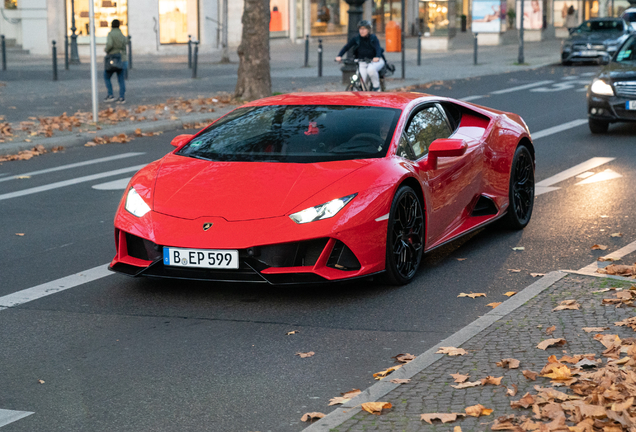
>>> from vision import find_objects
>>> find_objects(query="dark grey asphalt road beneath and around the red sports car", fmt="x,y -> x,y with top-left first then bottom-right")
0,66 -> 636,432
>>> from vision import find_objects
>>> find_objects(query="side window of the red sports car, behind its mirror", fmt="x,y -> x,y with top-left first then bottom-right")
398,105 -> 452,160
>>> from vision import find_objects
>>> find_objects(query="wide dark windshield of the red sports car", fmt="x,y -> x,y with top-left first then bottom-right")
177,105 -> 401,163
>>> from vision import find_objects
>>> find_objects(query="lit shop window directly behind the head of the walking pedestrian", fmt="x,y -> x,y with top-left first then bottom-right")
66,0 -> 128,44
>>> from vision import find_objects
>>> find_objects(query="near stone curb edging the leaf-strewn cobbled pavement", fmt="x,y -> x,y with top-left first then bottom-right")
303,270 -> 568,432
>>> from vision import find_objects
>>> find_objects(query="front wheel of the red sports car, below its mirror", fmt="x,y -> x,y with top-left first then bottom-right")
385,186 -> 425,285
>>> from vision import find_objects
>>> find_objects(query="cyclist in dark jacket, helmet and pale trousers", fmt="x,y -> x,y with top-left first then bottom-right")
336,20 -> 385,91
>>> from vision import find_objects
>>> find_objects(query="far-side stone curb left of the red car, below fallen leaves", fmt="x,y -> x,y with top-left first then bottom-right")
0,107 -> 234,156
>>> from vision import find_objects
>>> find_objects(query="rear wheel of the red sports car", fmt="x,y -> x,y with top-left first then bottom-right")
505,144 -> 534,230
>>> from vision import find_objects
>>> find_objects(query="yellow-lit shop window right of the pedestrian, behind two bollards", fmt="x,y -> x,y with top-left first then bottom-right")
159,0 -> 198,44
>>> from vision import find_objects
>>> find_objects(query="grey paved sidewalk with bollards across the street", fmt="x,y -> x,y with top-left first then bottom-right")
0,32 -> 560,155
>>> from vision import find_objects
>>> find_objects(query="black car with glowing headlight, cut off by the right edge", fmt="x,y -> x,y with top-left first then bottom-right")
587,35 -> 636,133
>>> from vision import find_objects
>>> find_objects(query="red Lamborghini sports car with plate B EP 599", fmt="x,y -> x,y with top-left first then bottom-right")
110,92 -> 535,284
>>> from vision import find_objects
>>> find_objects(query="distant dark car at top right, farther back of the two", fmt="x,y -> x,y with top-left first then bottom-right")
561,18 -> 633,66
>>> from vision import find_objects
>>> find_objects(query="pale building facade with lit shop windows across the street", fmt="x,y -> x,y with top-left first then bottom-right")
0,0 -> 629,55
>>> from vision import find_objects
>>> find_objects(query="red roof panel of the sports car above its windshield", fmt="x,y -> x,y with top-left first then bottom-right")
245,92 -> 438,109
